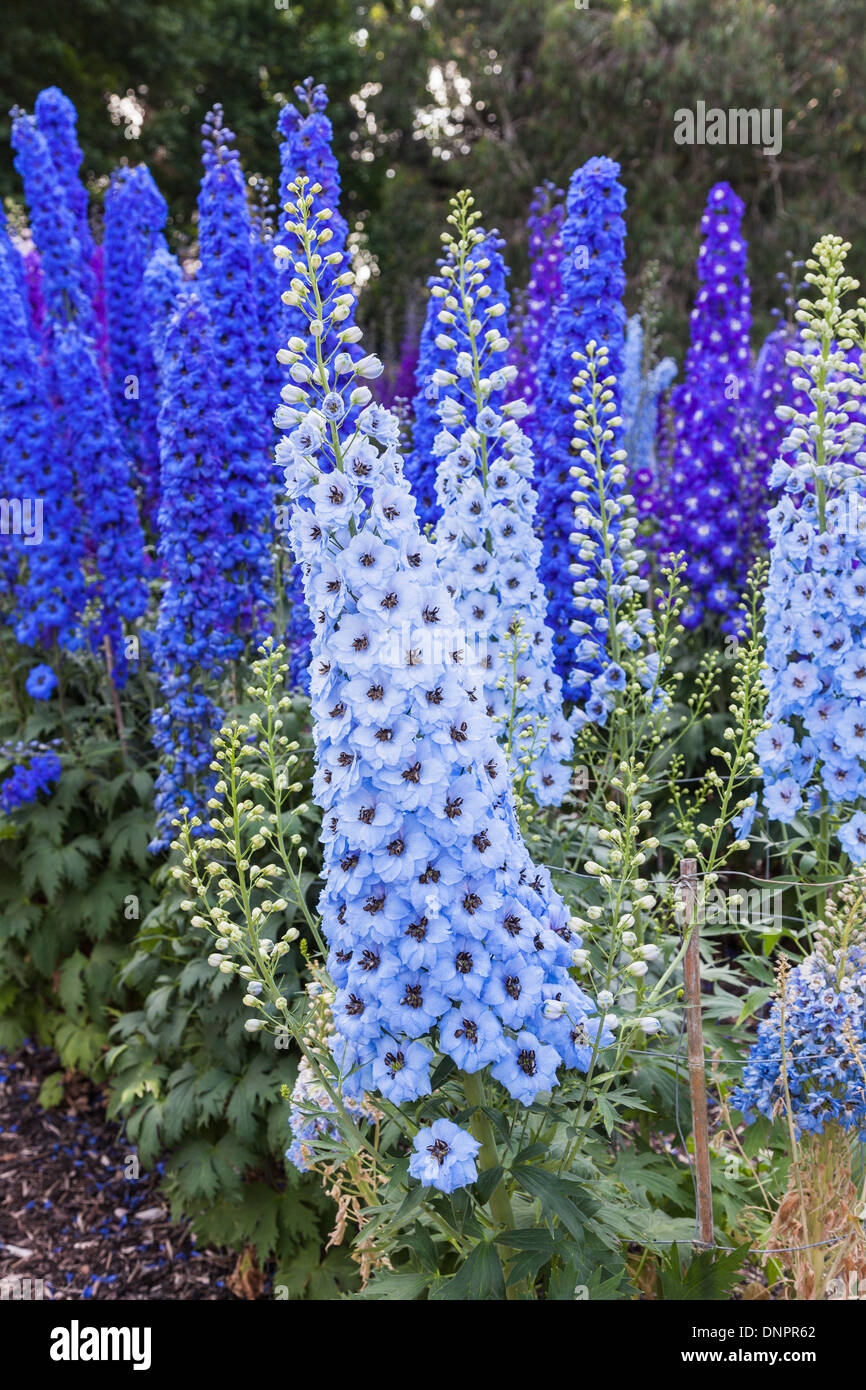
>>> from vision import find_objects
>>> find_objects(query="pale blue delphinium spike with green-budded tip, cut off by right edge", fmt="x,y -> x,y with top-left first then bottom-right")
756,236 -> 866,863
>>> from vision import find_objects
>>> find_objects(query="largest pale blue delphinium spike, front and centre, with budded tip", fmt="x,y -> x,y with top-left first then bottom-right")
275,168 -> 601,1178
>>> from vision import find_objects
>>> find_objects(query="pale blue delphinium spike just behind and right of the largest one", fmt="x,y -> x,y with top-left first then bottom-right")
431,192 -> 573,806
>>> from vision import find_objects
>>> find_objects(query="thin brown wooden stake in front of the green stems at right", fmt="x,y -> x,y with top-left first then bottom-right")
680,859 -> 714,1247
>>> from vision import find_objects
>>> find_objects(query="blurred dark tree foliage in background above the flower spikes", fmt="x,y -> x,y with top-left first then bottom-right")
0,0 -> 866,352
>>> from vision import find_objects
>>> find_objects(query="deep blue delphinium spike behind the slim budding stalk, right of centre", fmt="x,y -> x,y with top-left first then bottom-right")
534,158 -> 626,694
